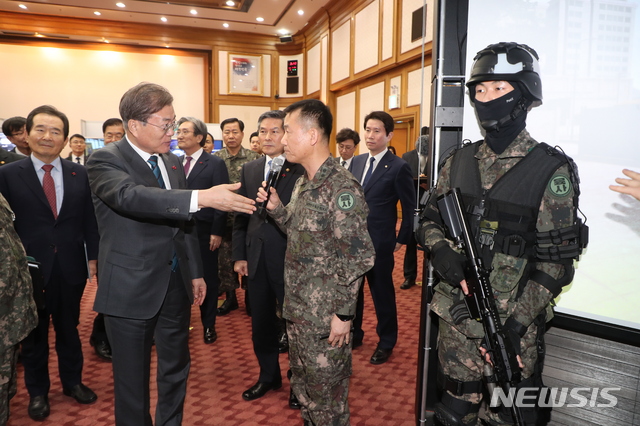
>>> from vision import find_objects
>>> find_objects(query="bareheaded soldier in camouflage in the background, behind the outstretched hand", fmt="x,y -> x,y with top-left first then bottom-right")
213,118 -> 260,315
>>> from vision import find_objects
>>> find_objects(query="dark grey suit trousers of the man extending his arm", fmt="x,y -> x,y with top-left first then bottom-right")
105,268 -> 191,426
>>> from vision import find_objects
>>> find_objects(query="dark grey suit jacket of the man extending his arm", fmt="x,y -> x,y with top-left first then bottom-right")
87,139 -> 202,319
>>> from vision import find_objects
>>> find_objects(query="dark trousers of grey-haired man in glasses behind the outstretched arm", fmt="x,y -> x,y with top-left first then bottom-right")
197,222 -> 220,328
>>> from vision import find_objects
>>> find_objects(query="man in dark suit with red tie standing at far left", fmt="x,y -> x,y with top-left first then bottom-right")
0,105 -> 99,420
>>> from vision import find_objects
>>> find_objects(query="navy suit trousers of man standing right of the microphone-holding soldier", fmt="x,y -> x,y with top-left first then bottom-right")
353,250 -> 398,349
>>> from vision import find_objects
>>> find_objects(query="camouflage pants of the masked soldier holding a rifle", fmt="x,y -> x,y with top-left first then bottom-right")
438,319 -> 538,425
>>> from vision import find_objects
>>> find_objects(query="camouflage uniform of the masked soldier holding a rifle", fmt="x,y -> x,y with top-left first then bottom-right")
418,130 -> 574,424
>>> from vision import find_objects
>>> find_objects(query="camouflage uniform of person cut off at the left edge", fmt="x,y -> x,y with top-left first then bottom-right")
0,194 -> 38,425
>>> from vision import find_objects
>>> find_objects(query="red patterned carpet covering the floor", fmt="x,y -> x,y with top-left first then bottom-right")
8,245 -> 422,426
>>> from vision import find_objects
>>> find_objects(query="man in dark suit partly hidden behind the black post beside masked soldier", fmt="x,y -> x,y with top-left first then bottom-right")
400,133 -> 429,290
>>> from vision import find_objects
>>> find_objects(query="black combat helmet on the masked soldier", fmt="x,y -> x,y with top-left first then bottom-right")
466,42 -> 542,107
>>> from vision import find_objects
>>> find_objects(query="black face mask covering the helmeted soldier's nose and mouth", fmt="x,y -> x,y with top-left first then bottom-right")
474,84 -> 527,154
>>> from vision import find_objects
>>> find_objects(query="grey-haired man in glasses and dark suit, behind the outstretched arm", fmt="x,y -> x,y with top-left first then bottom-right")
176,117 -> 229,344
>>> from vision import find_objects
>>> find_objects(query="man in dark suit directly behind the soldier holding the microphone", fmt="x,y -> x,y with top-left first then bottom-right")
232,111 -> 304,402
